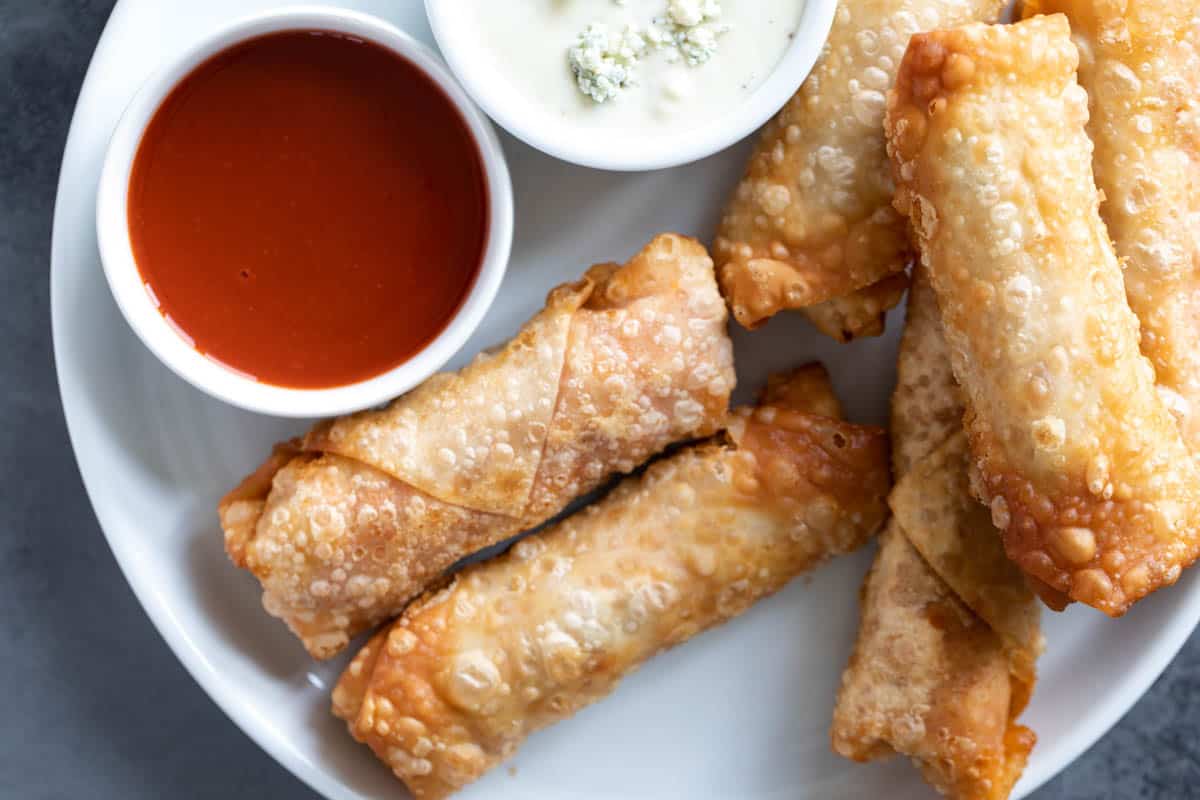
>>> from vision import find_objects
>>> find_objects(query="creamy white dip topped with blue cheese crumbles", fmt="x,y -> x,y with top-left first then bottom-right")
455,0 -> 804,132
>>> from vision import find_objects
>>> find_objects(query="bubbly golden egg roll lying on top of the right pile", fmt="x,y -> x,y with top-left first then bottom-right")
887,14 -> 1200,615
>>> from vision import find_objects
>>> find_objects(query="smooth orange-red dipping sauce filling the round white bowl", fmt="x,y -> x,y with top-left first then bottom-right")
128,31 -> 488,389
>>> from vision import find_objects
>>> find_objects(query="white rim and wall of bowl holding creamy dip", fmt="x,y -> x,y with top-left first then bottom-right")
425,0 -> 838,172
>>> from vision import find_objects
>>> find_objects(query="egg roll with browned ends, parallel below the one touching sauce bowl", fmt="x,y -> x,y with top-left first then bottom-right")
334,367 -> 889,798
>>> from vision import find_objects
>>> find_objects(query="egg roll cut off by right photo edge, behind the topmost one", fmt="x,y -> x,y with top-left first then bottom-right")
1025,0 -> 1200,455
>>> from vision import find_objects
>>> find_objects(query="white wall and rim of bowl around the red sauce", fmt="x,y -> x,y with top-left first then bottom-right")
96,6 -> 512,417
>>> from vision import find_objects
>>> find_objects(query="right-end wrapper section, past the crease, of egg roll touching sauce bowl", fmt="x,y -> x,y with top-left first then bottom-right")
524,236 -> 736,522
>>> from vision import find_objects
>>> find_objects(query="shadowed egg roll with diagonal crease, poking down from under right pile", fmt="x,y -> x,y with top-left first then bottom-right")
832,267 -> 1042,800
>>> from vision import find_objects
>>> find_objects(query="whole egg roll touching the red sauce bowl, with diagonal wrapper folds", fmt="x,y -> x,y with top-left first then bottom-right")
221,235 -> 734,657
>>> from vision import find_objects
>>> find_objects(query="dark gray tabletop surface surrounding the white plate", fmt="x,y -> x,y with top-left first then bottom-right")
0,0 -> 1200,800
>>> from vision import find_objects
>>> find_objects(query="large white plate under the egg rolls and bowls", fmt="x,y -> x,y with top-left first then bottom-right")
52,0 -> 1200,800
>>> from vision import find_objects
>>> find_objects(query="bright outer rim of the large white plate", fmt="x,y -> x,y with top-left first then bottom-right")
48,0 -> 1200,800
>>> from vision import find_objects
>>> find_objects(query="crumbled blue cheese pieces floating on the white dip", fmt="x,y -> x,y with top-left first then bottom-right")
566,0 -> 730,103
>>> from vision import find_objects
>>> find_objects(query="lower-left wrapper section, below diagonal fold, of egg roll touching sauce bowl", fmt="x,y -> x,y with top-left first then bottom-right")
241,453 -> 511,658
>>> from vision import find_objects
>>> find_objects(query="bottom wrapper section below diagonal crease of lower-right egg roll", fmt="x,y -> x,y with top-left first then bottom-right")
833,519 -> 1034,800
